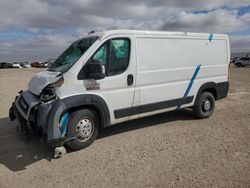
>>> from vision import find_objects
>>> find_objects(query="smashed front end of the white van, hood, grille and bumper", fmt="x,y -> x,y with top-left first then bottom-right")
9,71 -> 71,147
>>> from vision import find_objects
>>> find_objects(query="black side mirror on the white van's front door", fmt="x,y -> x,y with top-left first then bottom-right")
77,62 -> 106,80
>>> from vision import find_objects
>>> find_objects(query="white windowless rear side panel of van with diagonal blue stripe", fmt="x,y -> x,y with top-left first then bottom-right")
136,35 -> 229,117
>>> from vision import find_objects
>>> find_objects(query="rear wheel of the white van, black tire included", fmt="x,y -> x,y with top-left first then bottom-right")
193,92 -> 215,119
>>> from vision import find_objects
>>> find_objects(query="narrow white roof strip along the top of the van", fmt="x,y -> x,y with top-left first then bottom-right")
90,29 -> 228,39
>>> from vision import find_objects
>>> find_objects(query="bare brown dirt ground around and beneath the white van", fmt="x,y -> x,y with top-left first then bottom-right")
0,68 -> 250,188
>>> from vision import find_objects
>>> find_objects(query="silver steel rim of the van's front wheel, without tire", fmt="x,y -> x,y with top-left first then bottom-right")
76,118 -> 94,142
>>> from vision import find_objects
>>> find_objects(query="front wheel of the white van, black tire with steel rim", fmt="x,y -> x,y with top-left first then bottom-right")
67,109 -> 99,150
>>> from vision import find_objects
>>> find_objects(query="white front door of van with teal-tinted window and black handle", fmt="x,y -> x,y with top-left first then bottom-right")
86,36 -> 138,124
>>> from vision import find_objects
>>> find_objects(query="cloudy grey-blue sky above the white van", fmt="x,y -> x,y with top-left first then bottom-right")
0,0 -> 250,61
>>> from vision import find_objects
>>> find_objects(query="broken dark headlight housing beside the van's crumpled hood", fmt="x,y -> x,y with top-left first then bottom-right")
40,77 -> 64,102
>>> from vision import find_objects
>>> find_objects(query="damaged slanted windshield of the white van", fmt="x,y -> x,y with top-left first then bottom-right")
47,36 -> 98,73
